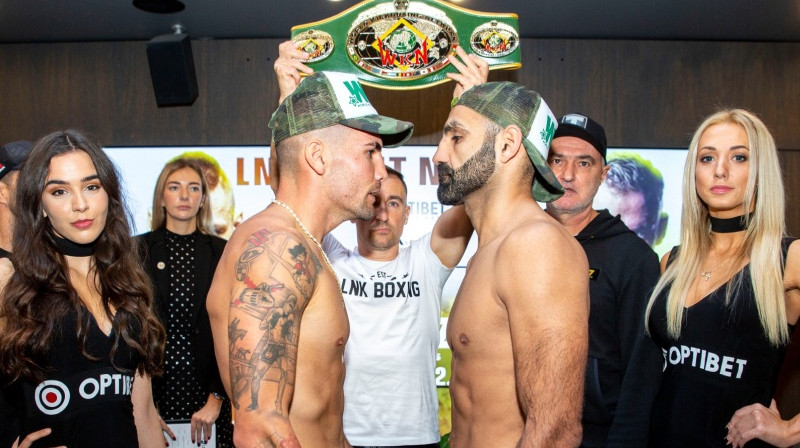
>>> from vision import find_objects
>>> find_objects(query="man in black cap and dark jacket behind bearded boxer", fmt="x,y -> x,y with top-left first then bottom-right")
547,113 -> 661,447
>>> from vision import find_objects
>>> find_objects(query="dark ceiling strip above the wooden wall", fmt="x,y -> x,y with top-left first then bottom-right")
0,0 -> 800,43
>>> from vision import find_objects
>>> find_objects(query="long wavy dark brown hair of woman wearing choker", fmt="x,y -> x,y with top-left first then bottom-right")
0,130 -> 165,381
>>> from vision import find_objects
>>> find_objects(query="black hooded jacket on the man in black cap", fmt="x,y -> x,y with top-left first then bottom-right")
575,210 -> 661,448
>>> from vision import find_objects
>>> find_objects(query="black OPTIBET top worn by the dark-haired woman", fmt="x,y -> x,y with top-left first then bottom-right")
15,311 -> 140,448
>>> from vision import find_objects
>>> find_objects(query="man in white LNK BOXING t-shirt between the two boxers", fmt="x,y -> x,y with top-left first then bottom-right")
322,167 -> 472,448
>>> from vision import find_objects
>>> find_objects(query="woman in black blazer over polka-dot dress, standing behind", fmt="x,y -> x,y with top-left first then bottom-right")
137,158 -> 233,447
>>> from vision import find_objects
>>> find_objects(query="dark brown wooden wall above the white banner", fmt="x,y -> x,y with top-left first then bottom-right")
0,39 -> 800,424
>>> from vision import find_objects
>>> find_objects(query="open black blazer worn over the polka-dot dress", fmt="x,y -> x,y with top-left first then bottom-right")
136,227 -> 226,397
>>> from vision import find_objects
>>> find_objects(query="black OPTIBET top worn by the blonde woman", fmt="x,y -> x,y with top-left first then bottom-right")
649,239 -> 792,448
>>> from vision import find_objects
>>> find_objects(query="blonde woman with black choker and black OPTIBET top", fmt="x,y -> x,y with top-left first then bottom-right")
646,109 -> 800,447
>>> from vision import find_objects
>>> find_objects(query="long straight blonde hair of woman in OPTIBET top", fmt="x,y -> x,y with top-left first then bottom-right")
645,109 -> 789,345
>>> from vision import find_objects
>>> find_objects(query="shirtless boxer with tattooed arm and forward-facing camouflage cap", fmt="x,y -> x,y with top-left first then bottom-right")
207,67 -> 413,448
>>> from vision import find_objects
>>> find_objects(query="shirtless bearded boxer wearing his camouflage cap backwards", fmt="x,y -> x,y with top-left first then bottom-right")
434,82 -> 589,448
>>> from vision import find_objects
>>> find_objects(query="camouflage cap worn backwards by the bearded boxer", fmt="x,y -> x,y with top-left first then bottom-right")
453,81 -> 564,202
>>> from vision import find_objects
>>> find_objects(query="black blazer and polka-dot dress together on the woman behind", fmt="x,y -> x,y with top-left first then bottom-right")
138,227 -> 233,447
